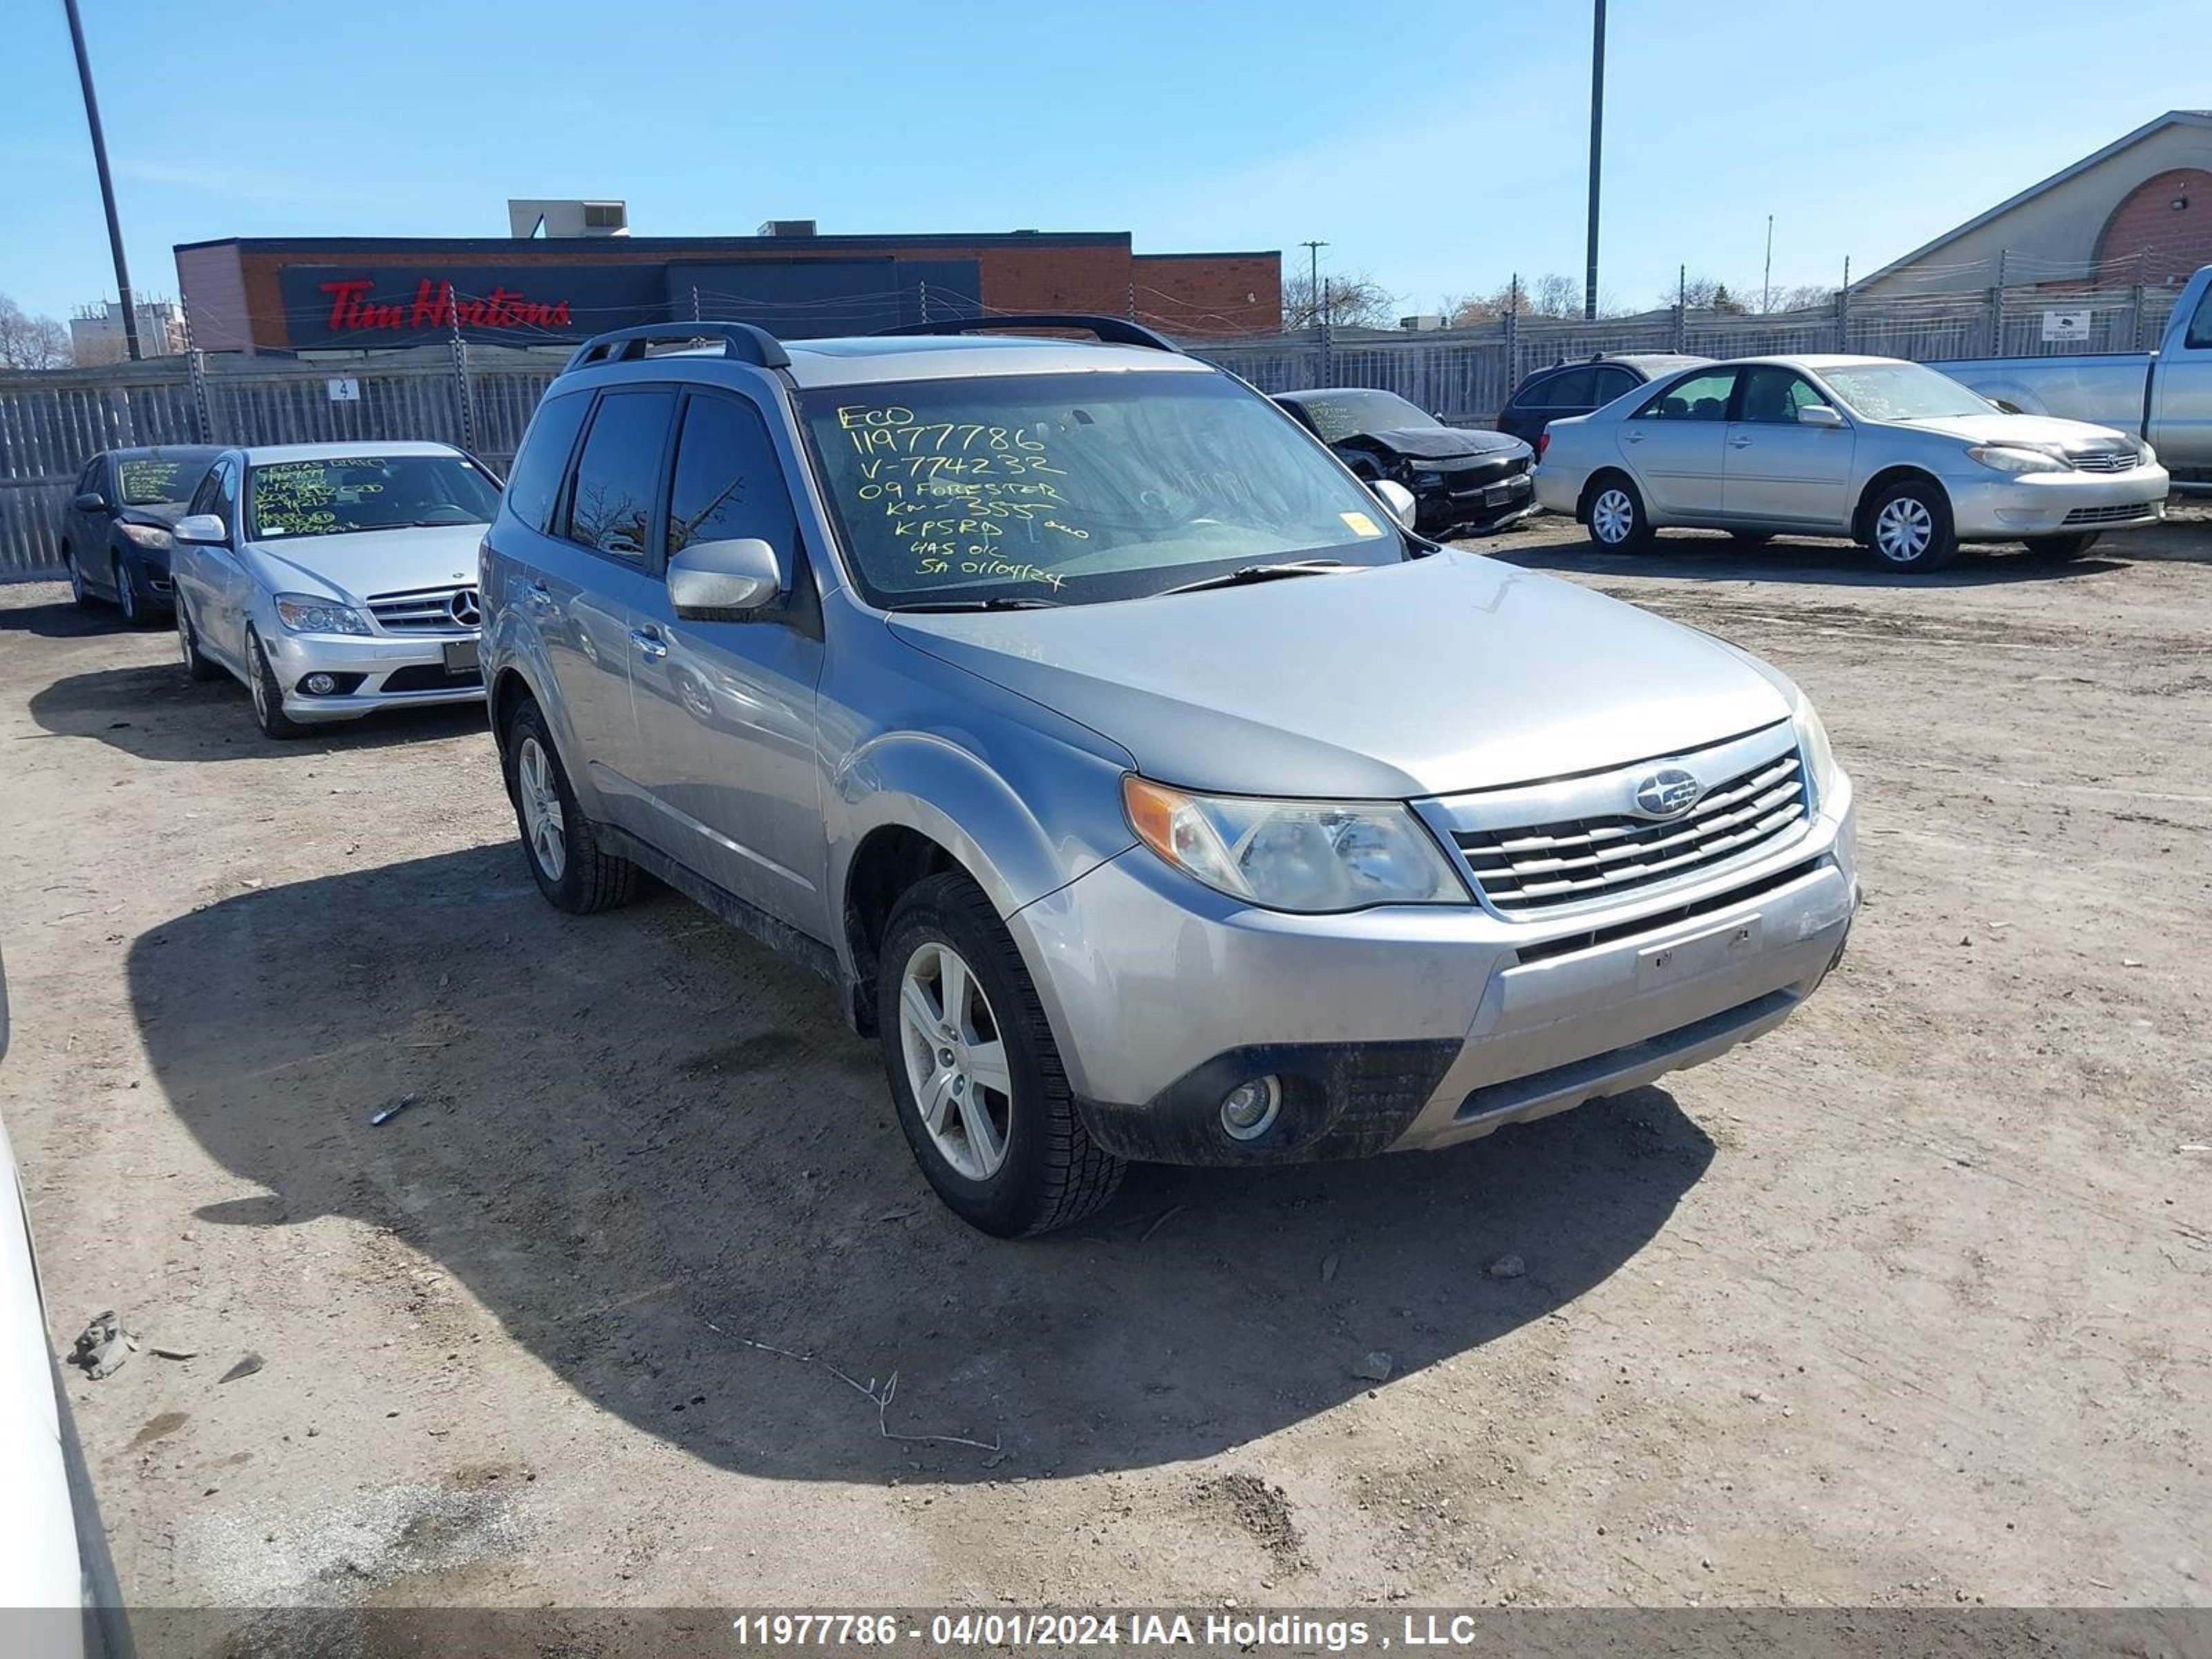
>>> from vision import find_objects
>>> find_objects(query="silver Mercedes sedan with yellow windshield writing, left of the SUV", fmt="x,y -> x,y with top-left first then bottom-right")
170,442 -> 500,737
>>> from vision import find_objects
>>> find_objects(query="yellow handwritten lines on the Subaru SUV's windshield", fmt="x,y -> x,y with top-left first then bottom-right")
836,402 -> 1091,588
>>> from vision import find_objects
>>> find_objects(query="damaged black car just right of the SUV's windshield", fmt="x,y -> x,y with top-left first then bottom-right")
1276,387 -> 1535,535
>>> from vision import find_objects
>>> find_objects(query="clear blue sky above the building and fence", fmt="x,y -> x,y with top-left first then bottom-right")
0,0 -> 2212,327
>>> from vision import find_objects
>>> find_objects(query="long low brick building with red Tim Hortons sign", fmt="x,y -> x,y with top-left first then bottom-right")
177,221 -> 1283,352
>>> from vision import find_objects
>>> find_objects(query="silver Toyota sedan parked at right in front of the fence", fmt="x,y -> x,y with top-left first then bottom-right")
1535,356 -> 2168,571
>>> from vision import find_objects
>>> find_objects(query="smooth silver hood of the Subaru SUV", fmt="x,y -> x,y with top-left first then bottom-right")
889,553 -> 1790,800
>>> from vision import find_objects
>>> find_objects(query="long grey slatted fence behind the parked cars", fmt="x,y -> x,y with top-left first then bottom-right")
0,285 -> 2175,579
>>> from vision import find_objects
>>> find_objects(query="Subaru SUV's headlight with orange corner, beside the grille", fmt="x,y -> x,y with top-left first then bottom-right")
1121,774 -> 1469,914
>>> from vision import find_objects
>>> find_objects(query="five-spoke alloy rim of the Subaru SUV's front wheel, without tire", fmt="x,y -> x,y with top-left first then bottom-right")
898,940 -> 1013,1181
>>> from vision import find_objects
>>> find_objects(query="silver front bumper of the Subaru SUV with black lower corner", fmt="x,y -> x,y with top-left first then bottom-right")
1011,774 -> 1858,1163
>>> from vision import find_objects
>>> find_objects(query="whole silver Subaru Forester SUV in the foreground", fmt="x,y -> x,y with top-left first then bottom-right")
482,317 -> 1858,1235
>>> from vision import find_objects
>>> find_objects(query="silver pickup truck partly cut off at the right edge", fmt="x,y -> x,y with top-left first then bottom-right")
1929,265 -> 2212,485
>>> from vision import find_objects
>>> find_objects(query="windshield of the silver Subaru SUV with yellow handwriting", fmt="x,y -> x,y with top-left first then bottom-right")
803,372 -> 1405,606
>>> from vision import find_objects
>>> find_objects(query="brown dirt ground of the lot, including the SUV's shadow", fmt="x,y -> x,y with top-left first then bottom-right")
0,511 -> 2212,1637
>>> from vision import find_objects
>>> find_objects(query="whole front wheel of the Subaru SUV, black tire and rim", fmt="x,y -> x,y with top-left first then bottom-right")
876,872 -> 1126,1239
